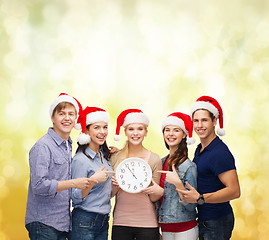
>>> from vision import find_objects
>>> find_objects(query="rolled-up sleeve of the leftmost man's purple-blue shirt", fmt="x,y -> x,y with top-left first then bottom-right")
29,145 -> 58,197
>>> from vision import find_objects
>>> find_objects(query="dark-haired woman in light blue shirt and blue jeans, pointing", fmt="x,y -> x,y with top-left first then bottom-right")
71,107 -> 114,240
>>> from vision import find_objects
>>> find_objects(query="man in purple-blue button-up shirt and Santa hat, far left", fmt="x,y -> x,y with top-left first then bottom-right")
25,93 -> 91,240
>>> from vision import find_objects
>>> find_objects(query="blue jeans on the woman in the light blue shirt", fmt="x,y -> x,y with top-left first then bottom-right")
70,208 -> 109,240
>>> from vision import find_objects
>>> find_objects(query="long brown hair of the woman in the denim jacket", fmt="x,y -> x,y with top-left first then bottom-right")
163,129 -> 188,171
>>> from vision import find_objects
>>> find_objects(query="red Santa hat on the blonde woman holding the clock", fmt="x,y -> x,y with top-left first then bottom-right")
114,109 -> 149,141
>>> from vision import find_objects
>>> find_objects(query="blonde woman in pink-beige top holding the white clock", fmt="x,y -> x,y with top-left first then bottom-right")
111,109 -> 162,240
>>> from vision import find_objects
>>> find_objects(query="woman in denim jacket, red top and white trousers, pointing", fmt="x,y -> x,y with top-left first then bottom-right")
144,112 -> 198,240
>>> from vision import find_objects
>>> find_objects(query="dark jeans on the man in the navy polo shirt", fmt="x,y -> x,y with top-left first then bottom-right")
198,213 -> 234,240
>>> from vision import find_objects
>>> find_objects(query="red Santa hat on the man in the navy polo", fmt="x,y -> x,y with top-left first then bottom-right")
191,96 -> 225,136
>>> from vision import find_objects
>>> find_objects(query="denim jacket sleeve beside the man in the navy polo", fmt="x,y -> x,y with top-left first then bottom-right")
180,163 -> 197,211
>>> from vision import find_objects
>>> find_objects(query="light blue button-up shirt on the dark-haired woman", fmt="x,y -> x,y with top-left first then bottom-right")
71,148 -> 112,214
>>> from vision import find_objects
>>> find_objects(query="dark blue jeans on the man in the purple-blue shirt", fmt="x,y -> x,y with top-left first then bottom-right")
25,222 -> 68,240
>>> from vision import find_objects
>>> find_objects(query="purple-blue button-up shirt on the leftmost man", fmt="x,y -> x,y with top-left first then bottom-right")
25,128 -> 72,231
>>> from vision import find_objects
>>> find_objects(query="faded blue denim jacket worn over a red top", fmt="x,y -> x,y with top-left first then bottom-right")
159,156 -> 197,223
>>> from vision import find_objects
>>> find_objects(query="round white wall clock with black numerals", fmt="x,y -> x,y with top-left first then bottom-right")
116,157 -> 152,193
